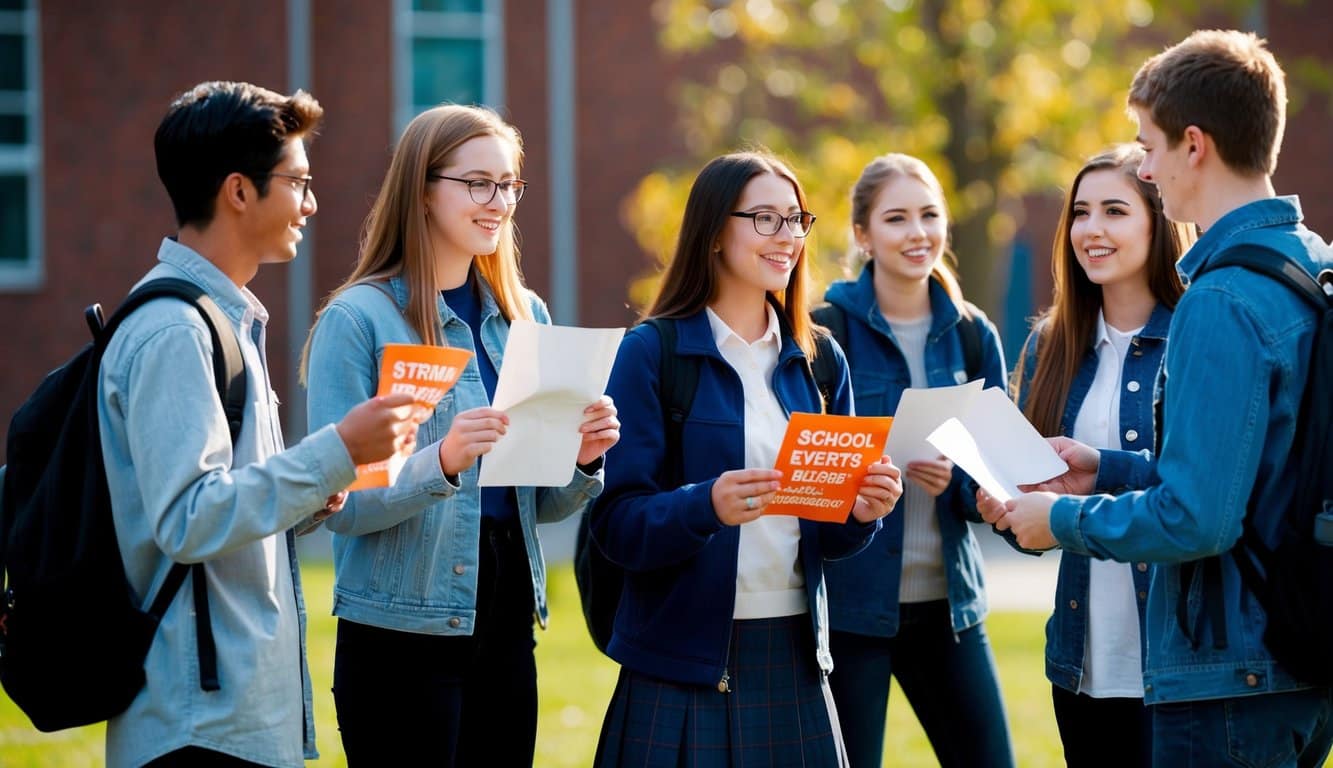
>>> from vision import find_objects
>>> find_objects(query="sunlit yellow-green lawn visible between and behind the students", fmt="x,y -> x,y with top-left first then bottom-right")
0,563 -> 1141,768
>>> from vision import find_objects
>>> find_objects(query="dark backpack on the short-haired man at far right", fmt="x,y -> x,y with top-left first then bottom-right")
1199,245 -> 1333,685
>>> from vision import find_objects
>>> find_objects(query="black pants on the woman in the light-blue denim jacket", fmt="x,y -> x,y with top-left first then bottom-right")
333,521 -> 537,767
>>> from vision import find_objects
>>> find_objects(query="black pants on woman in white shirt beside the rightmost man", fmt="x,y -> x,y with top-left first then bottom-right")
1050,685 -> 1153,768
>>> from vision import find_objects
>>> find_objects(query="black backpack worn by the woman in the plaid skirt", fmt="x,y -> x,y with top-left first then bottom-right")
575,317 -> 841,653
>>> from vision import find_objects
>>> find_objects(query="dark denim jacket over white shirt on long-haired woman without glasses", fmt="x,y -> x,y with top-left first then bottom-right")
1018,304 -> 1172,693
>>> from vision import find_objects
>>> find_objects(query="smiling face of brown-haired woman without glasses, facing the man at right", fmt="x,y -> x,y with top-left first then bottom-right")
1069,168 -> 1153,288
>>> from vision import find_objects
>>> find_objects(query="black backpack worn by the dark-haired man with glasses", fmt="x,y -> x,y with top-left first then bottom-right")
0,279 -> 245,731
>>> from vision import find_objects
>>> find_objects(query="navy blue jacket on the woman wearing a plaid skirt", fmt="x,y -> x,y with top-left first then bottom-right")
592,311 -> 880,687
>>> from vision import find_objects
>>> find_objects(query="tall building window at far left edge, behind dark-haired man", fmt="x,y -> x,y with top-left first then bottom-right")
0,0 -> 41,288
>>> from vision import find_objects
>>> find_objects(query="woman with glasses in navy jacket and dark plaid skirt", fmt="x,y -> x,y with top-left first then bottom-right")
592,152 -> 902,767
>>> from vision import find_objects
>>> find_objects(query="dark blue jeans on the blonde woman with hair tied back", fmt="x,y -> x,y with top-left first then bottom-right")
829,600 -> 1014,768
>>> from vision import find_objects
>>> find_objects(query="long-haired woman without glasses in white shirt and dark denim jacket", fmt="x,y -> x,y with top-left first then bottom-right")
1014,144 -> 1194,768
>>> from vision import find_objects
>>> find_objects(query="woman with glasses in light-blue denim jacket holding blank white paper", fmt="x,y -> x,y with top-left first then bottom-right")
305,105 -> 620,765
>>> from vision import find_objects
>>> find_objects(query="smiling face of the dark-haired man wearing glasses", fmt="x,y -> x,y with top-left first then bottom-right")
247,139 -> 319,264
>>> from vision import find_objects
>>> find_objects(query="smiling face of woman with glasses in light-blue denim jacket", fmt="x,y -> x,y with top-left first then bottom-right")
425,135 -> 519,264
